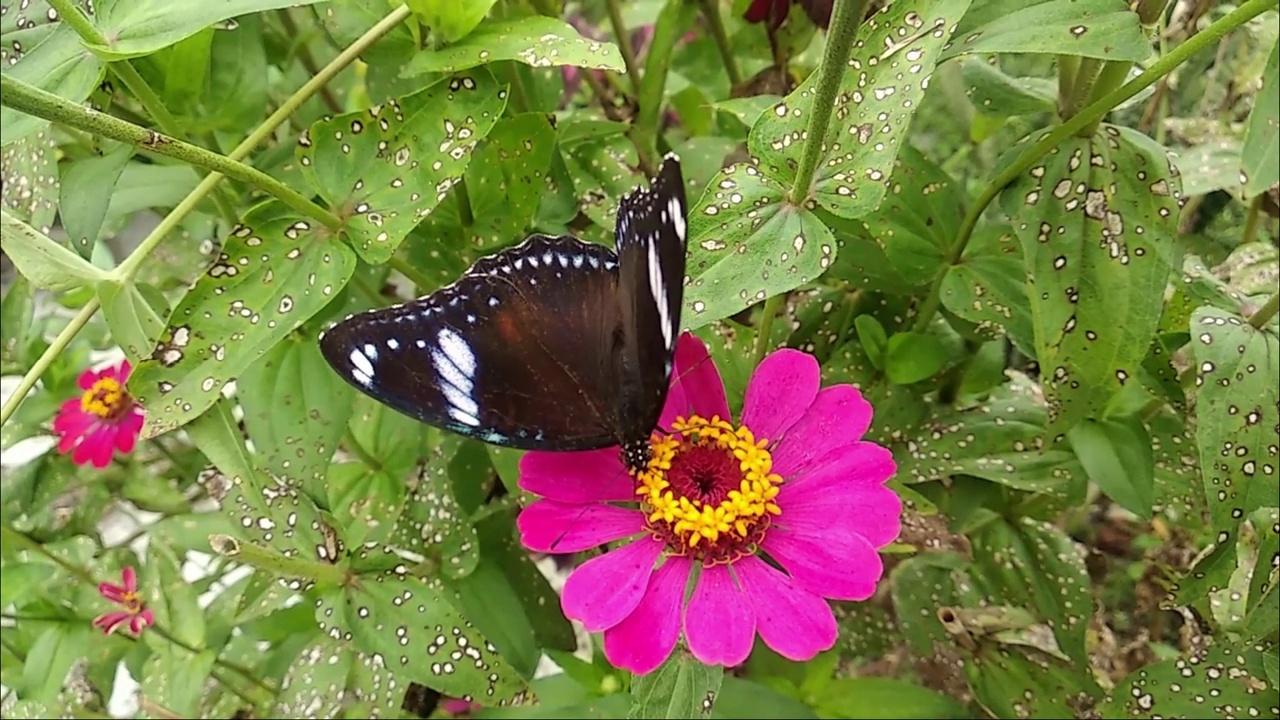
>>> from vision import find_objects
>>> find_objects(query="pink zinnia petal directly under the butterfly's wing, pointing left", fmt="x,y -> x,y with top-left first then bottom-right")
520,447 -> 635,503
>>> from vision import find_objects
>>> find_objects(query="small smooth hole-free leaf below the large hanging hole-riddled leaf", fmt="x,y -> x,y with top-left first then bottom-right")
1066,420 -> 1156,518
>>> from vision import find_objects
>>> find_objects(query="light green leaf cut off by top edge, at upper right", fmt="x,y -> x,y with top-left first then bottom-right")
943,0 -> 1151,63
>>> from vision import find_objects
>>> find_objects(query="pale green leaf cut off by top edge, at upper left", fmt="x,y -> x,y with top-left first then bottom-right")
90,0 -> 319,60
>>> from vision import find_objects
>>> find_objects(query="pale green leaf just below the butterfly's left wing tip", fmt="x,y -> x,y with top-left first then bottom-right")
236,334 -> 356,489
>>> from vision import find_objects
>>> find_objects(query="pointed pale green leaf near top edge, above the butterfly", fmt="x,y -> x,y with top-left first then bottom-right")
401,15 -> 626,77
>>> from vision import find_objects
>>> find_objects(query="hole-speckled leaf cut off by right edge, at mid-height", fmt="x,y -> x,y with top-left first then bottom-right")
1190,307 -> 1280,530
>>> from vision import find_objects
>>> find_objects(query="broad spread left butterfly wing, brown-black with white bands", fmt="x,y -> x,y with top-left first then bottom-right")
320,234 -> 618,450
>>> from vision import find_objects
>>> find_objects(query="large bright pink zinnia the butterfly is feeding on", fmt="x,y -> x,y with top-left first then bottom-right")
518,333 -> 902,674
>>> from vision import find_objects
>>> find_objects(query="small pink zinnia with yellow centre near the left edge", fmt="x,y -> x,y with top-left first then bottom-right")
54,360 -> 142,468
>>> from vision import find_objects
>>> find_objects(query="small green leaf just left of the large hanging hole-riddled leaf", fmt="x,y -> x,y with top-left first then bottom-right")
942,225 -> 1036,355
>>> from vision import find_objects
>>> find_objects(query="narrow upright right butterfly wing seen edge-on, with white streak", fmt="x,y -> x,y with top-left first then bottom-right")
617,155 -> 687,442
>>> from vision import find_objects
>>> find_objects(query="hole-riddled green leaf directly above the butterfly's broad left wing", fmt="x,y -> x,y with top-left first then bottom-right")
297,68 -> 507,264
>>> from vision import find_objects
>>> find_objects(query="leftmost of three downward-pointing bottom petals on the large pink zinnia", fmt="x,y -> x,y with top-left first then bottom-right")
604,556 -> 692,675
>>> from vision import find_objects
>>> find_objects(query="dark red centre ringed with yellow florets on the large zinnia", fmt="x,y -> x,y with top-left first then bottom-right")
635,415 -> 782,564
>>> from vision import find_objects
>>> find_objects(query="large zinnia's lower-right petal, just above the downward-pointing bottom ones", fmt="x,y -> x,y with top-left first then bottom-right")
760,519 -> 884,600
